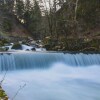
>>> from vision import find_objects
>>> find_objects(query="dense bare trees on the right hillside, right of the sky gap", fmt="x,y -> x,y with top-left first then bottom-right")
50,0 -> 100,36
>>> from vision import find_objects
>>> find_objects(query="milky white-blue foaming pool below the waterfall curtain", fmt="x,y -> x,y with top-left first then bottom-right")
0,63 -> 100,100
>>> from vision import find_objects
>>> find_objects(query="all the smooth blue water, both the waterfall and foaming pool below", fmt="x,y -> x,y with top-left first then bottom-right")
0,52 -> 100,100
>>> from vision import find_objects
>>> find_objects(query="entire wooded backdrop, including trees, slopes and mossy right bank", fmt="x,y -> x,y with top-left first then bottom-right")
0,0 -> 100,51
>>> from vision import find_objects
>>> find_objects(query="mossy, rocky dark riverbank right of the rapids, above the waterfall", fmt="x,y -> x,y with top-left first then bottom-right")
43,37 -> 100,52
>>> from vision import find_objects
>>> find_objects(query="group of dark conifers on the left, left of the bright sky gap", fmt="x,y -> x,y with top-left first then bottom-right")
0,0 -> 42,37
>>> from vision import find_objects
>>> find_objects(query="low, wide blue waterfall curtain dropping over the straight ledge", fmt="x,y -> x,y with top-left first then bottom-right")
0,52 -> 100,71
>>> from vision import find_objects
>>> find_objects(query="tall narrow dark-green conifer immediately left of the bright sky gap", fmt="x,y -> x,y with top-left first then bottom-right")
28,0 -> 41,37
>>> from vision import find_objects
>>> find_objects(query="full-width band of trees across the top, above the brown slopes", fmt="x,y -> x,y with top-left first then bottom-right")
0,0 -> 100,40
